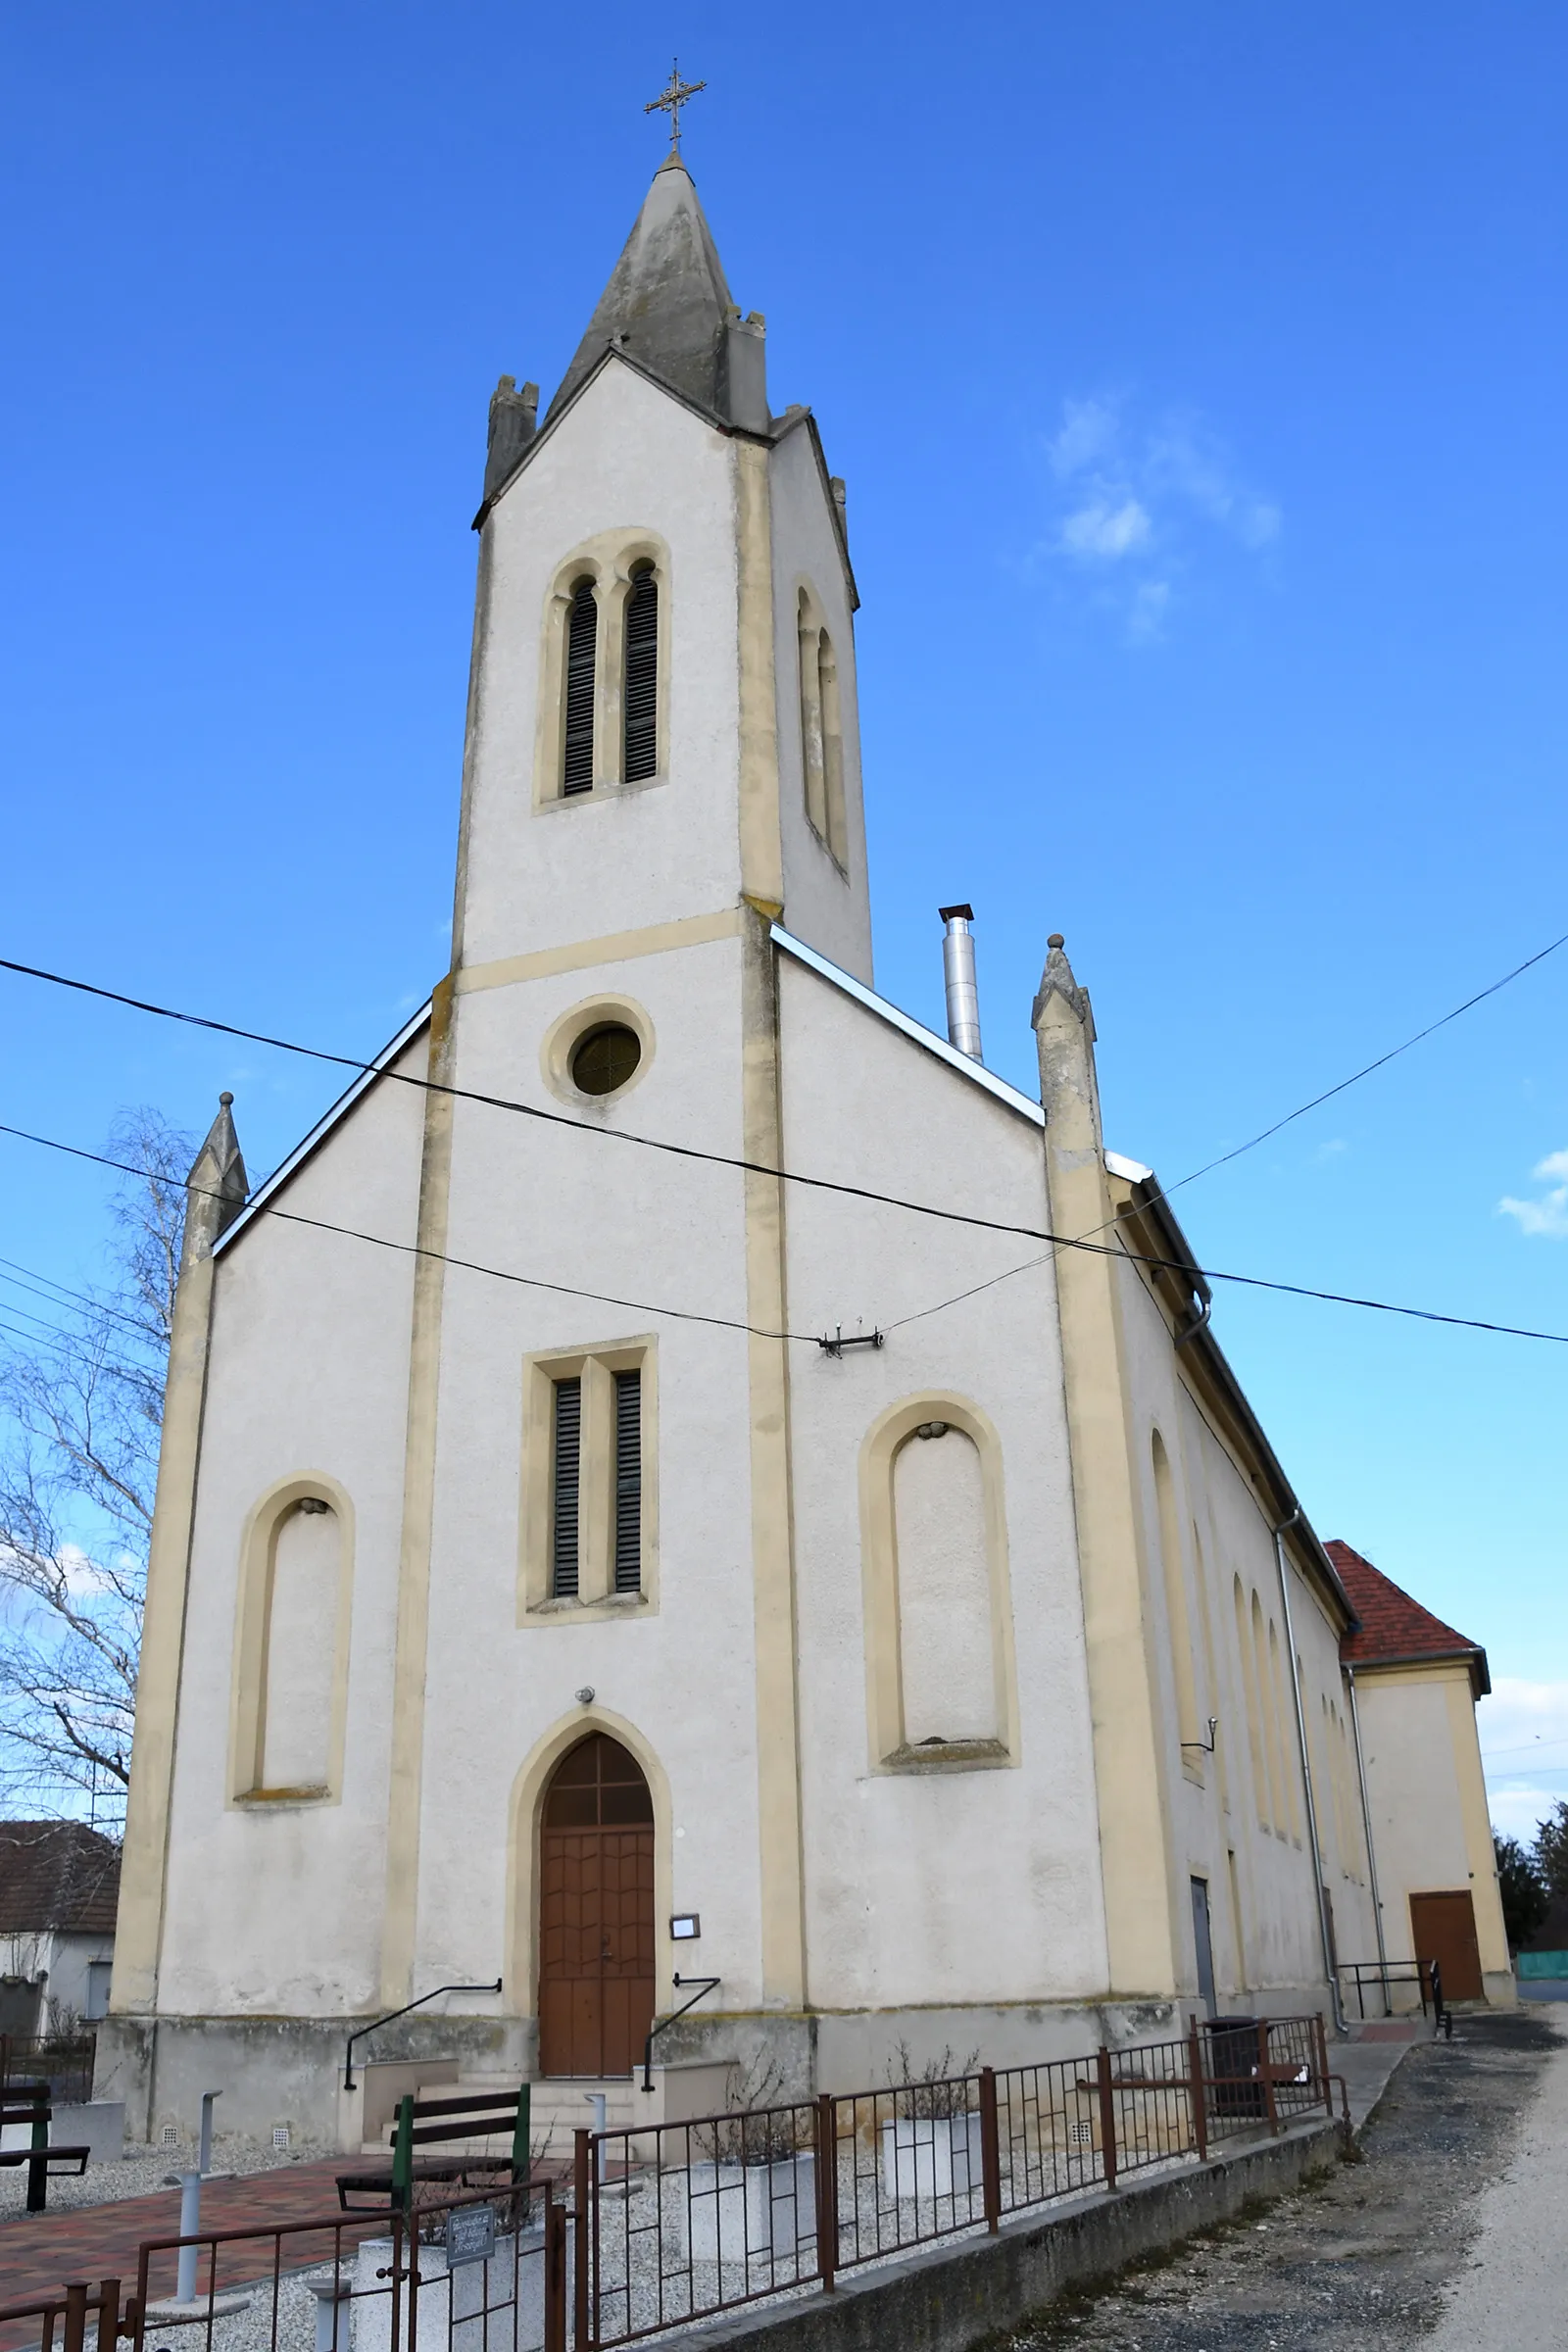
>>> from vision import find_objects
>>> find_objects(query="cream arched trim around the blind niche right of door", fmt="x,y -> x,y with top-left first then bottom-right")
860,1388 -> 1020,1774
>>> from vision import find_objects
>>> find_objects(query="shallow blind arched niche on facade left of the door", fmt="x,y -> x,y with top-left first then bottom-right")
232,1487 -> 350,1799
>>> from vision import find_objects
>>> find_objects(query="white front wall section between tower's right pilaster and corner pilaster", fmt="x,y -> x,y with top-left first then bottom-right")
780,959 -> 1107,2032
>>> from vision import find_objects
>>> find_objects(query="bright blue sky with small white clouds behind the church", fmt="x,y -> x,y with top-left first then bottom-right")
0,0 -> 1568,1823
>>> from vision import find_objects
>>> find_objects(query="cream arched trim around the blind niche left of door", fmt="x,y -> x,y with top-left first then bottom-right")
228,1470 -> 355,1806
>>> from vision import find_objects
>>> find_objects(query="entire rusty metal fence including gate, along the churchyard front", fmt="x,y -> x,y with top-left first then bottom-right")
0,2018 -> 1336,2352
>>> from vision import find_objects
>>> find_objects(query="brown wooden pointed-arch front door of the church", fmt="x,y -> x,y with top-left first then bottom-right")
538,1731 -> 654,2077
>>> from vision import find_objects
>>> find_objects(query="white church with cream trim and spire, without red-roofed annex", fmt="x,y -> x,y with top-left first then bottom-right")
99,142 -> 1502,2140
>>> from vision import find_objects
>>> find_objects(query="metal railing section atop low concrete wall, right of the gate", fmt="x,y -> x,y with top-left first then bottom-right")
571,2018 -> 1333,2352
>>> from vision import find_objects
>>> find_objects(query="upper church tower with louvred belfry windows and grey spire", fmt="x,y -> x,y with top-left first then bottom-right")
454,151 -> 870,983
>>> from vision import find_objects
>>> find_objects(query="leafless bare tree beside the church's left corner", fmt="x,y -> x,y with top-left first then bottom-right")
0,1107 -> 195,1830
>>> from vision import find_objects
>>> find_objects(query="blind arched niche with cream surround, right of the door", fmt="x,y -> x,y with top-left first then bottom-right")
860,1397 -> 1018,1771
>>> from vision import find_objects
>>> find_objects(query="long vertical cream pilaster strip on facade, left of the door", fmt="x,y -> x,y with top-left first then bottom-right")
381,981 -> 456,2009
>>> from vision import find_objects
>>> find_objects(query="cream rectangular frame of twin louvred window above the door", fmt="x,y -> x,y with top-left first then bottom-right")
517,1331 -> 659,1625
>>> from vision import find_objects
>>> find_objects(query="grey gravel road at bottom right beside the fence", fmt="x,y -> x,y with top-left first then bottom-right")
992,2009 -> 1568,2352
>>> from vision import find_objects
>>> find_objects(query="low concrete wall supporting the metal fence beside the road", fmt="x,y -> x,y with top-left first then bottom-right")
670,2124 -> 1340,2352
